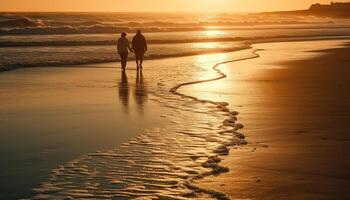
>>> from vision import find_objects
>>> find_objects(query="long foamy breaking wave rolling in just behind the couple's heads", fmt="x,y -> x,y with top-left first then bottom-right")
0,23 -> 349,35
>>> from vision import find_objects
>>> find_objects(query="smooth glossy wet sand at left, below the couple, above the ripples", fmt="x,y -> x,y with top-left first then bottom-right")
0,66 -> 165,199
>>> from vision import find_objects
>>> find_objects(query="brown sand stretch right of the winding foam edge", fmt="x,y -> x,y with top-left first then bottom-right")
186,41 -> 350,199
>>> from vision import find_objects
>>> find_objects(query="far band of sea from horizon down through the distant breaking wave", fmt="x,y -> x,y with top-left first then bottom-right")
0,13 -> 339,35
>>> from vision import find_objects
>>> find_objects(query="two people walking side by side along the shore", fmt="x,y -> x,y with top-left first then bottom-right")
117,30 -> 147,71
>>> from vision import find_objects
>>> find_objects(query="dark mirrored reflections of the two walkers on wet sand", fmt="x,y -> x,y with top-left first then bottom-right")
118,71 -> 148,114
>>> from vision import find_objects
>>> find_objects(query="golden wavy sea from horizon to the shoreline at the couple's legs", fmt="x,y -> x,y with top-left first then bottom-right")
0,13 -> 350,69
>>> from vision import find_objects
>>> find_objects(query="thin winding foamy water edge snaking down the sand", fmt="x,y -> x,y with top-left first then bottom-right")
169,49 -> 263,200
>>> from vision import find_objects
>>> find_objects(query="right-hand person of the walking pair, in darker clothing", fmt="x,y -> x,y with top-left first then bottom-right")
132,30 -> 147,70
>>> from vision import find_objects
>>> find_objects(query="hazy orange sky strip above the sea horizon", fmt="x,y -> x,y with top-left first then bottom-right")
0,0 -> 349,12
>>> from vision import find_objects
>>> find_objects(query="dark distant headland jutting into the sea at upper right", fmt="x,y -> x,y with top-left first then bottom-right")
264,2 -> 350,18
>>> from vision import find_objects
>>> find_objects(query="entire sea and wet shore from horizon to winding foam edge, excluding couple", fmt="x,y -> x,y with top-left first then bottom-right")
0,13 -> 350,199
